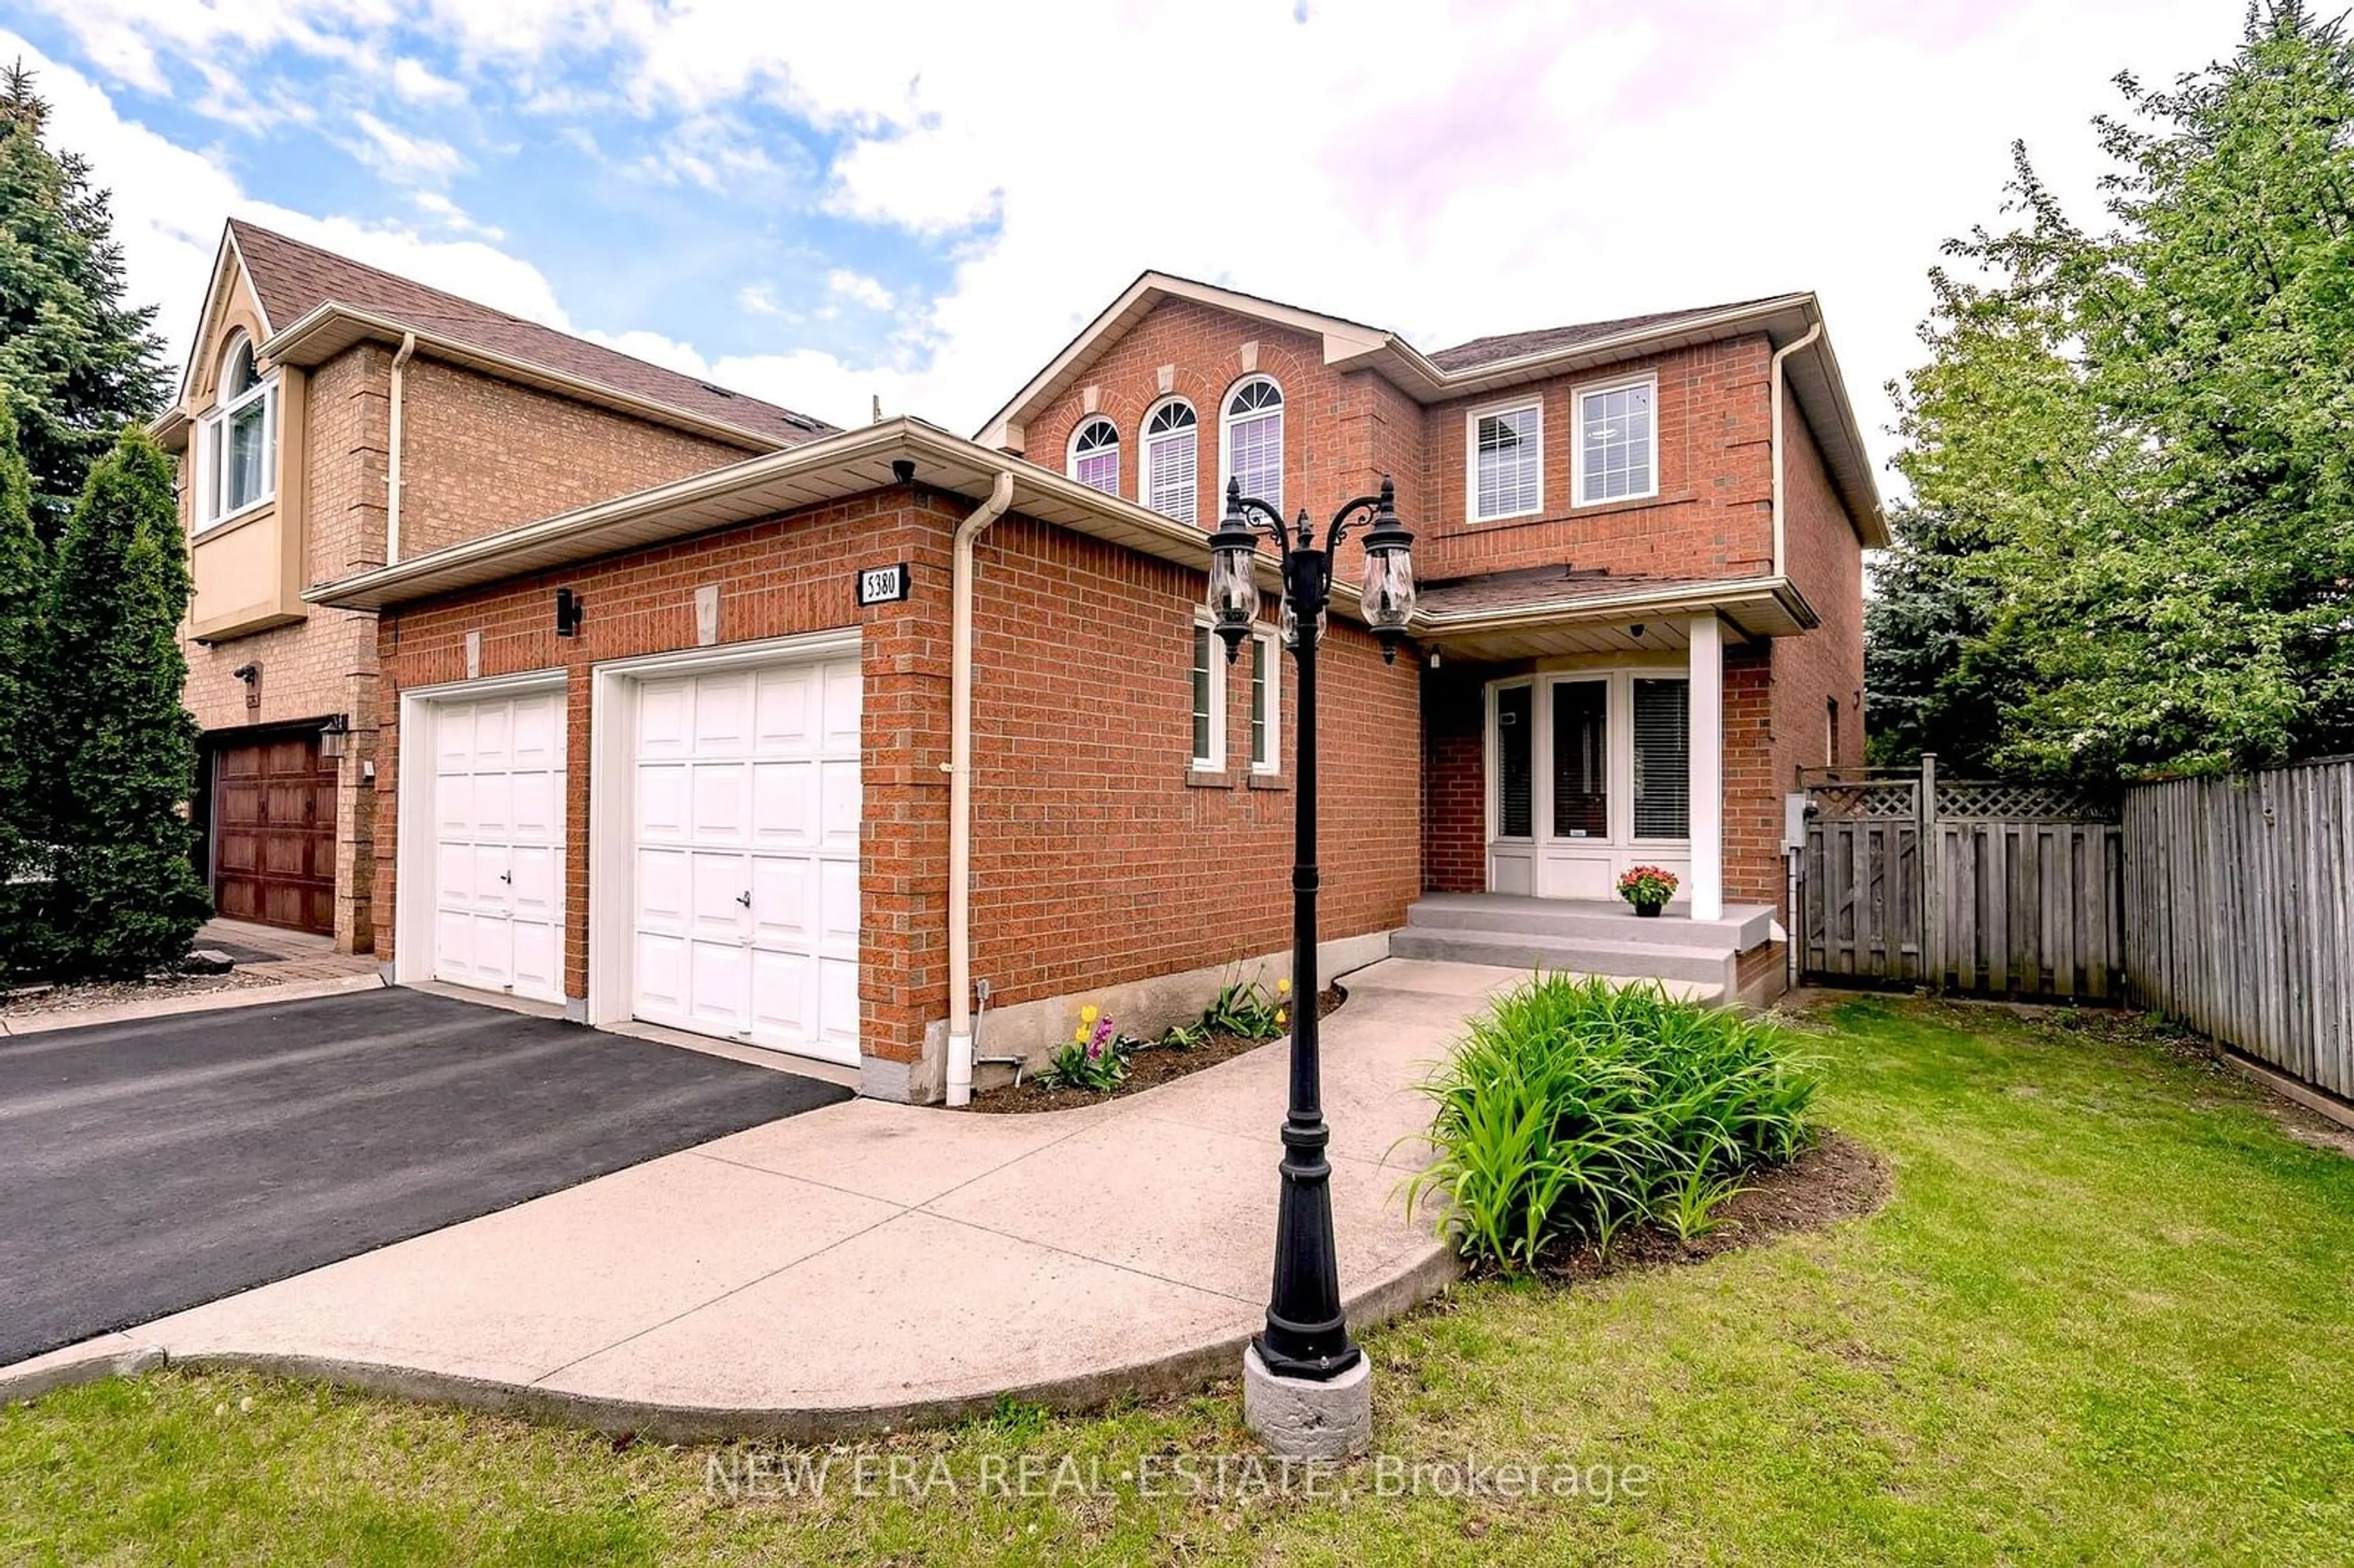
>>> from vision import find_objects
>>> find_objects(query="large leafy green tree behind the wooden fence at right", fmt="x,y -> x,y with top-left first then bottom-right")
1869,2 -> 2354,779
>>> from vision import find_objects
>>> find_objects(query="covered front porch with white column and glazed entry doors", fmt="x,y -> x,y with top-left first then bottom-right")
1424,568 -> 1813,927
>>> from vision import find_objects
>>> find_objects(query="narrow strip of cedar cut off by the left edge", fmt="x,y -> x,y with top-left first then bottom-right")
0,381 -> 50,984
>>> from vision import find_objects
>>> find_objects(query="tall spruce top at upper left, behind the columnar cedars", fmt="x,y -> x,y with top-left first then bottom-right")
0,61 -> 165,539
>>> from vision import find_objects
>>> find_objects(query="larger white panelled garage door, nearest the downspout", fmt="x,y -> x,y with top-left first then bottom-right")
631,657 -> 859,1064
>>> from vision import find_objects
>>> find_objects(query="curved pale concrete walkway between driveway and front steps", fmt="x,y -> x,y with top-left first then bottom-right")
0,958 -> 1521,1441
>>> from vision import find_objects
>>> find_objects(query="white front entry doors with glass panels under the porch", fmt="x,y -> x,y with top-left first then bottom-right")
1488,669 -> 1690,899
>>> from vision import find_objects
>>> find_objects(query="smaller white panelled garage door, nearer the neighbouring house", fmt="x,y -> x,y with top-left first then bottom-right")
433,690 -> 565,1000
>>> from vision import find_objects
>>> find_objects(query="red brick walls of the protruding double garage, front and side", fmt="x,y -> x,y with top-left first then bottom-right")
375,490 -> 1420,1062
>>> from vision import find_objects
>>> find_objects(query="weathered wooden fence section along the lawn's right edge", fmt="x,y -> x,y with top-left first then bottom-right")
2124,758 -> 2354,1097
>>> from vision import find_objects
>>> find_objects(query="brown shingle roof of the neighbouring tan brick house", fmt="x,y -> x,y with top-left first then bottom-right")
228,219 -> 833,445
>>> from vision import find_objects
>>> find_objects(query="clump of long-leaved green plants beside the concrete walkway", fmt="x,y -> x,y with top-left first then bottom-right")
1407,975 -> 1819,1269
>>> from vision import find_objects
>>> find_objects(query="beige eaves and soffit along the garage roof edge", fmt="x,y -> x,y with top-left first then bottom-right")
303,417 -> 1361,619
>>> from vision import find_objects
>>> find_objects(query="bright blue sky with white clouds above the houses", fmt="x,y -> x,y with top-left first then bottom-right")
0,0 -> 2241,480
